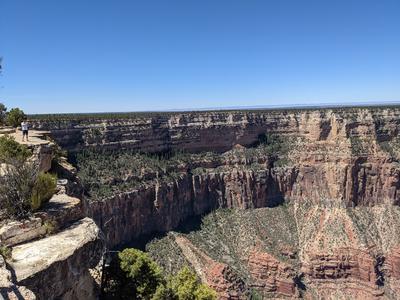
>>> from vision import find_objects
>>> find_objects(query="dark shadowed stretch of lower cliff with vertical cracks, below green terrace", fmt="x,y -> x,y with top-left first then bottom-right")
87,171 -> 300,247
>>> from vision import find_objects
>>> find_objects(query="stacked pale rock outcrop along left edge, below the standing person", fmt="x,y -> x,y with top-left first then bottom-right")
0,132 -> 104,300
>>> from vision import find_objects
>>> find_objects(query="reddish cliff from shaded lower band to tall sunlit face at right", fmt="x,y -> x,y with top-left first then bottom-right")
81,106 -> 400,246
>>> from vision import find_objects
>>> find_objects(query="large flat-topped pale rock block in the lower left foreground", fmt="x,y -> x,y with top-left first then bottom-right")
10,218 -> 102,299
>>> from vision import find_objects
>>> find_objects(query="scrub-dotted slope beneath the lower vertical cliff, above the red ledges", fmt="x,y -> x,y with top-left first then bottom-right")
146,200 -> 400,299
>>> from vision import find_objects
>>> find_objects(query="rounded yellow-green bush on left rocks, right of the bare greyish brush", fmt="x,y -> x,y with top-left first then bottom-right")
31,172 -> 57,211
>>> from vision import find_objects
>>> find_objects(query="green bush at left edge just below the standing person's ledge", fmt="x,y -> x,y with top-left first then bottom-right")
0,135 -> 32,163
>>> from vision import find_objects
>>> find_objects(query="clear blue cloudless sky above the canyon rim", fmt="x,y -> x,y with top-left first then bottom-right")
0,0 -> 400,113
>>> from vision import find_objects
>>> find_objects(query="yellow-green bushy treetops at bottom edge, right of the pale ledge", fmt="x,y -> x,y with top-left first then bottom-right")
105,248 -> 218,300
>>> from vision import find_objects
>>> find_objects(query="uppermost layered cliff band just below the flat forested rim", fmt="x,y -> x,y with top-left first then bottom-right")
30,107 -> 400,152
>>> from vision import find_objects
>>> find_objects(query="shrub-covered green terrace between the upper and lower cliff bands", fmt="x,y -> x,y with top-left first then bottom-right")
75,134 -> 292,199
